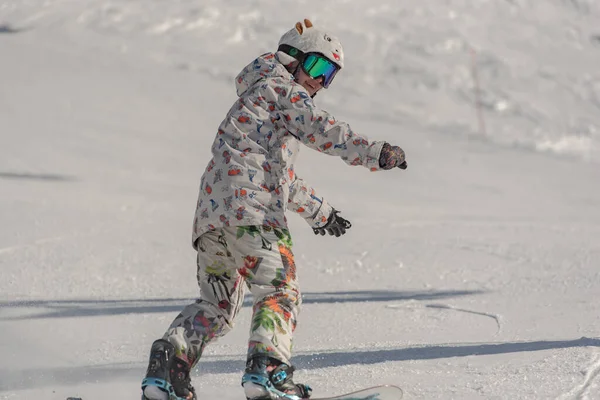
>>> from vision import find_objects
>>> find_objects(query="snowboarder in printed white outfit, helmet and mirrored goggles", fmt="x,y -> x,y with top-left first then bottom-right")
142,19 -> 407,400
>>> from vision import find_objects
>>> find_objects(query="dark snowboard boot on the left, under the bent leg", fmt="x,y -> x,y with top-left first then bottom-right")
142,339 -> 196,400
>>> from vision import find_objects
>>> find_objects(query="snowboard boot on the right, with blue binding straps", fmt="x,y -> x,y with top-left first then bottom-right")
242,356 -> 312,400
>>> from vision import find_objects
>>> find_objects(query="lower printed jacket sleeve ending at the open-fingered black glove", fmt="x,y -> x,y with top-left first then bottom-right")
287,176 -> 333,228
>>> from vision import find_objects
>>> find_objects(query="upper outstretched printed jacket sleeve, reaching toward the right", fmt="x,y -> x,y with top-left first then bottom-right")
272,82 -> 385,171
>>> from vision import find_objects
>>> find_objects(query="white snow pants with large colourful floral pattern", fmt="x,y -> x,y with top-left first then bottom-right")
164,226 -> 301,368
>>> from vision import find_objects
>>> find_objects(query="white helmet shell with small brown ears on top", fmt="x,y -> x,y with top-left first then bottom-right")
278,19 -> 344,69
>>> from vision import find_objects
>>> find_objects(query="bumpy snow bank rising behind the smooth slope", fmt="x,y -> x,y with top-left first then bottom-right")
0,0 -> 600,162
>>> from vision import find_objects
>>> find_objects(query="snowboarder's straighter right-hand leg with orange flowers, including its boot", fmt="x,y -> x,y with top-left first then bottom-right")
226,226 -> 310,399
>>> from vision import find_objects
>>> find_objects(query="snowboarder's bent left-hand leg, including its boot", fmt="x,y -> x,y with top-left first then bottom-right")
142,230 -> 245,400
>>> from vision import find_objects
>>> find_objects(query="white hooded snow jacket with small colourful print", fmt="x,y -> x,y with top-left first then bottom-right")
192,53 -> 384,247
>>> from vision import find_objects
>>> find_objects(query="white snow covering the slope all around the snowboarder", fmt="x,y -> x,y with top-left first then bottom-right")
0,0 -> 600,400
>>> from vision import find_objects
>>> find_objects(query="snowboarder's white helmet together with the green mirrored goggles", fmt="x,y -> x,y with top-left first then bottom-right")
277,19 -> 344,88
